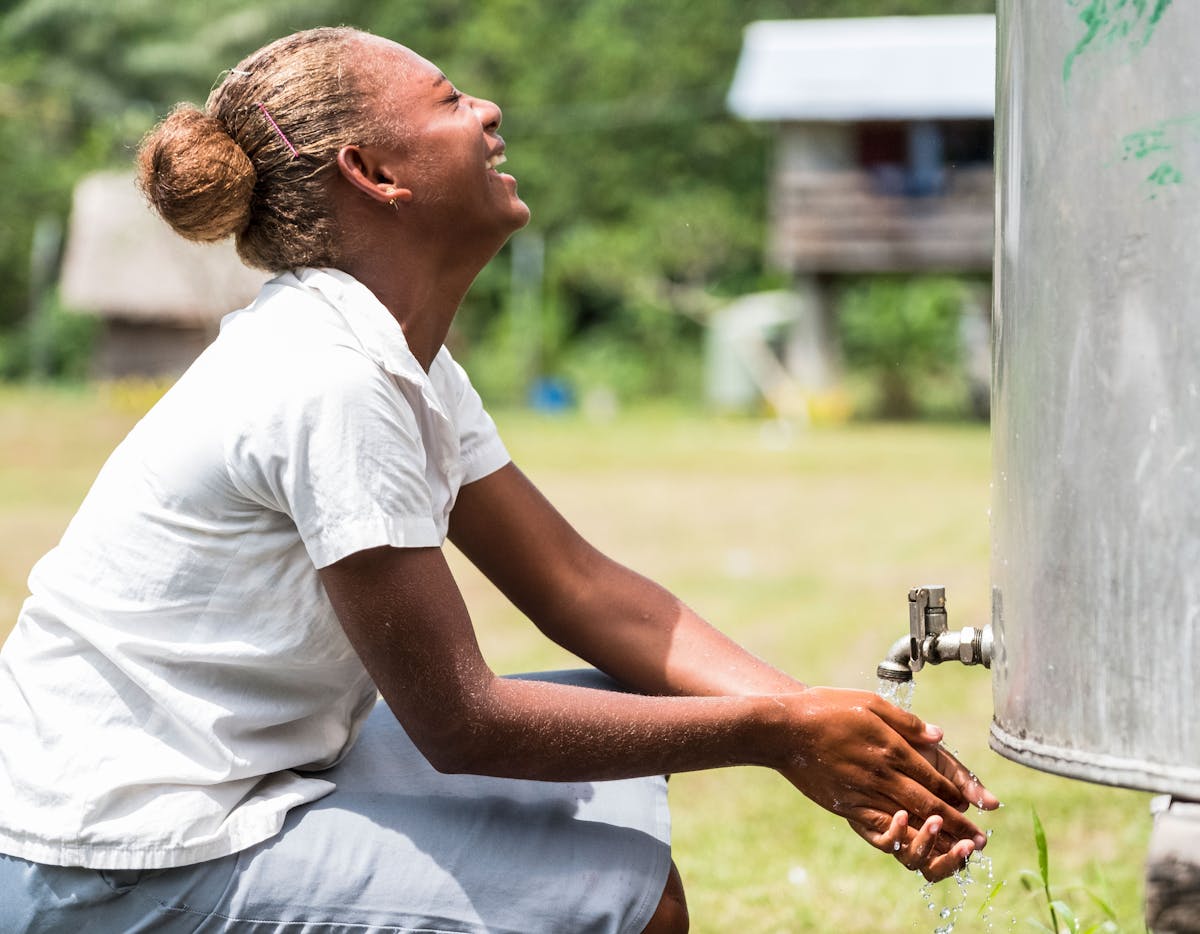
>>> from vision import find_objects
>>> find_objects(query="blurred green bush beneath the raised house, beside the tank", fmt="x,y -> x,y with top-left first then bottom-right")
836,276 -> 973,419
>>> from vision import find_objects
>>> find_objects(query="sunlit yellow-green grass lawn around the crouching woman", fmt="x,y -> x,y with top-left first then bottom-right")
0,389 -> 1150,934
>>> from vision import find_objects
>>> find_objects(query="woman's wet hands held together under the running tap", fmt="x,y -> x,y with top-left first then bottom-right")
780,688 -> 1000,879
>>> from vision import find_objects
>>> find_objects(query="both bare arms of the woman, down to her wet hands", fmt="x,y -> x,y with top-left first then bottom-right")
322,466 -> 998,878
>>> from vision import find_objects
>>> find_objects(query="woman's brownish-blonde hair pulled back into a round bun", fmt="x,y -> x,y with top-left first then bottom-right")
138,28 -> 378,273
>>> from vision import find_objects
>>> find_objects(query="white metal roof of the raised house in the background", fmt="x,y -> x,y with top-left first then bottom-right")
727,14 -> 996,120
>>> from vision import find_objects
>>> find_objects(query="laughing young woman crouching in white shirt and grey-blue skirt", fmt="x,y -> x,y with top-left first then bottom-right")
0,29 -> 996,932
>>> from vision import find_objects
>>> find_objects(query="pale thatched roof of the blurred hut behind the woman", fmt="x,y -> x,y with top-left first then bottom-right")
60,172 -> 268,327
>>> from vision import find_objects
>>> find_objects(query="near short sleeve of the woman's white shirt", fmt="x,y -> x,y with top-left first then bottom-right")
226,347 -> 442,568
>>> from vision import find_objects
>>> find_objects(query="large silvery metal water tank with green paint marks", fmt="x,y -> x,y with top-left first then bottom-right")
991,0 -> 1200,798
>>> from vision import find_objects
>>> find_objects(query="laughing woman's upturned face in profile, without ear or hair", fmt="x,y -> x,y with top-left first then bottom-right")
357,40 -> 529,237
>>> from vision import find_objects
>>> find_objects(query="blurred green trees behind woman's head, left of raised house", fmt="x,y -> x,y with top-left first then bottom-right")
0,0 -> 994,391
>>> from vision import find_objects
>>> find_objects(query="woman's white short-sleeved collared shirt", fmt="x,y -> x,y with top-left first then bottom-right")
0,269 -> 509,869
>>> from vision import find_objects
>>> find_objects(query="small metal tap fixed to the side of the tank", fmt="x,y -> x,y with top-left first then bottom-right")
875,587 -> 992,681
